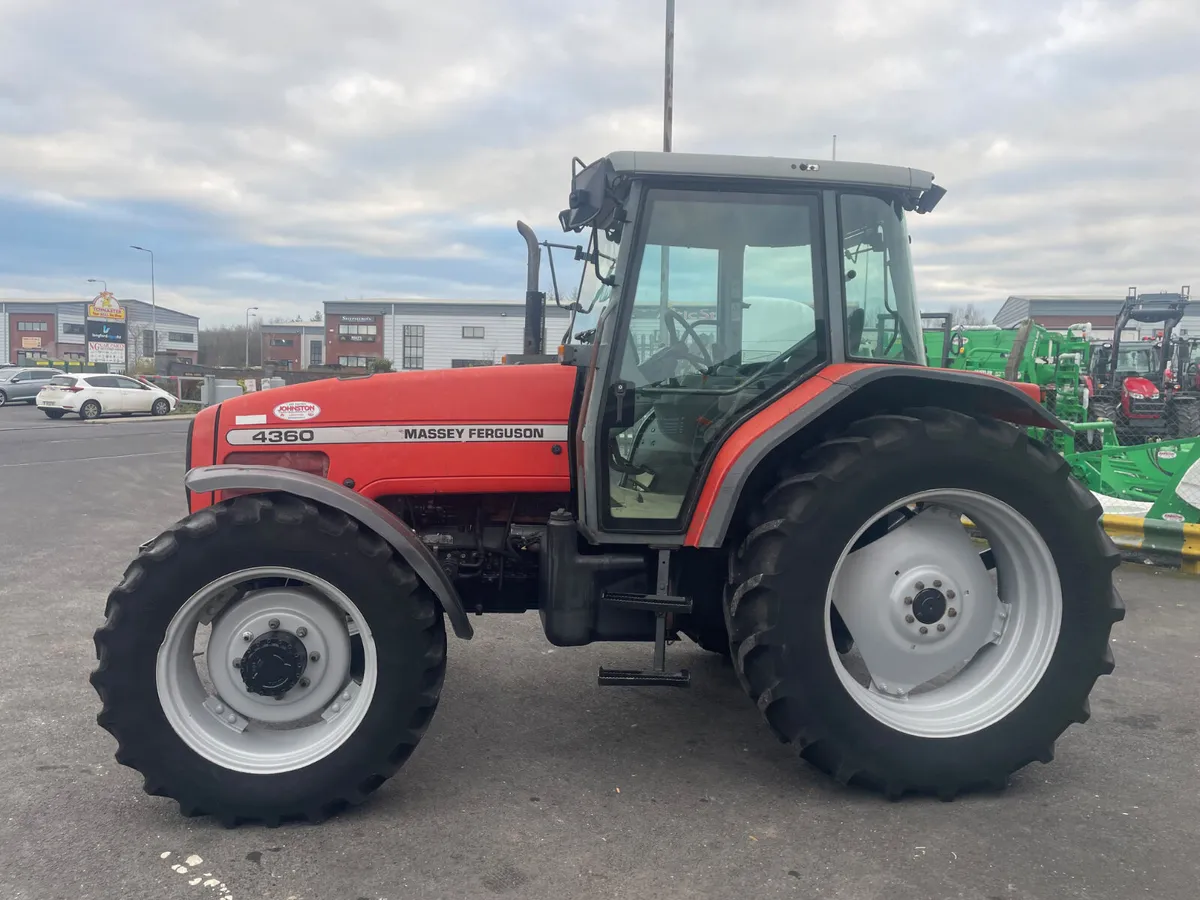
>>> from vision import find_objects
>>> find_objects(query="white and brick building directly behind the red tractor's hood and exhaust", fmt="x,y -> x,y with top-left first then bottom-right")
321,299 -> 570,371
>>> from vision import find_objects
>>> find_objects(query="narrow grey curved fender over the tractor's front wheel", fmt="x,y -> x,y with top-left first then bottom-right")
184,466 -> 475,640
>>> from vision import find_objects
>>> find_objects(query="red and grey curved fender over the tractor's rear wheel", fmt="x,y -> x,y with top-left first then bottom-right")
684,365 -> 1068,547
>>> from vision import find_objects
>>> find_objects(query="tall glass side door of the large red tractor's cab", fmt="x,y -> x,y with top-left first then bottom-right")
577,184 -> 829,546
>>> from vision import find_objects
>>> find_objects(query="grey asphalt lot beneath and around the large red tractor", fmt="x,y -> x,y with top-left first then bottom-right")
0,408 -> 1200,900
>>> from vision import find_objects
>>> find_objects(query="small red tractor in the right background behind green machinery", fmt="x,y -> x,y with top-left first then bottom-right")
1087,288 -> 1200,444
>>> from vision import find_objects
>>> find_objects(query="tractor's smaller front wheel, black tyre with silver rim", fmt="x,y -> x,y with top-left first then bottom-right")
91,494 -> 445,827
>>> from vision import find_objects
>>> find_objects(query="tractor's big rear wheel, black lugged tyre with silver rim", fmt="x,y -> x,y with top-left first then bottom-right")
726,409 -> 1124,799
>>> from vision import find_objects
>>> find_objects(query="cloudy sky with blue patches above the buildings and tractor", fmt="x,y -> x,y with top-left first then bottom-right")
0,0 -> 1200,324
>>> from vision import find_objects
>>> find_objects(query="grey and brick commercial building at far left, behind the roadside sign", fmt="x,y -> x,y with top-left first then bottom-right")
0,298 -> 200,370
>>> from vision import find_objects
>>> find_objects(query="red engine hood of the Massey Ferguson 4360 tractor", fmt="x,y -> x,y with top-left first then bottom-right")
196,364 -> 578,497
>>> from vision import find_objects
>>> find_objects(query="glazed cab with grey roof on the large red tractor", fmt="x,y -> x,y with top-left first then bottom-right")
559,152 -> 944,541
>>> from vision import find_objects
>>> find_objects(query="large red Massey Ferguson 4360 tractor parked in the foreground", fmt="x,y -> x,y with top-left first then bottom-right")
91,152 -> 1123,826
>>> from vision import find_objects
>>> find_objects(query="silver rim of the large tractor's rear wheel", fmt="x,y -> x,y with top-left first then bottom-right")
826,488 -> 1062,738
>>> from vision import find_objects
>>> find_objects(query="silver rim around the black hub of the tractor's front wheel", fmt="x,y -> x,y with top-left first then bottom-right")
156,566 -> 378,775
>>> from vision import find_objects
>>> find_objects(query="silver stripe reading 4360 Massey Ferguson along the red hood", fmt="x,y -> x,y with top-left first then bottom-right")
226,427 -> 566,445
